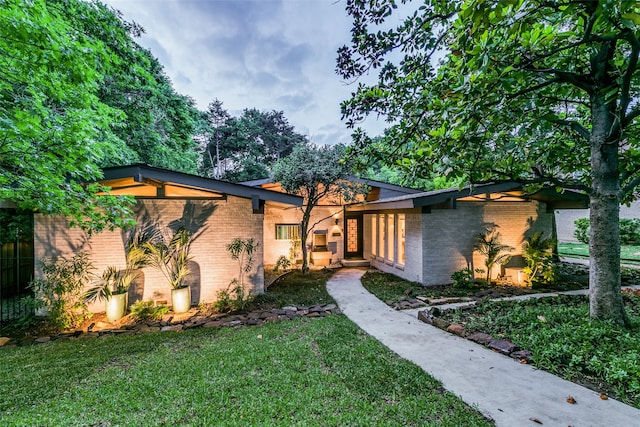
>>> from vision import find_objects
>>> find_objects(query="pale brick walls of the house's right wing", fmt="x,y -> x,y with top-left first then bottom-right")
364,201 -> 553,285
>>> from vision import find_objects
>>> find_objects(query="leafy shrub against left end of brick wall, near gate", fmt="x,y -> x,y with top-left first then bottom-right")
29,252 -> 93,330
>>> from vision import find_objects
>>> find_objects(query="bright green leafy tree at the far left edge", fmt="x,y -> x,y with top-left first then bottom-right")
0,0 -> 130,229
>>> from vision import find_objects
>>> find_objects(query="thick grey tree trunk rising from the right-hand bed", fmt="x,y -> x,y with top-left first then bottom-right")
589,95 -> 629,326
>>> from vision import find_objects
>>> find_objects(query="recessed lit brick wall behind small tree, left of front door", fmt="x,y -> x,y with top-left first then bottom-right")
264,206 -> 344,268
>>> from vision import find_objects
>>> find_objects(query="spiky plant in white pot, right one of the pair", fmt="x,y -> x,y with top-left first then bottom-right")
145,228 -> 192,313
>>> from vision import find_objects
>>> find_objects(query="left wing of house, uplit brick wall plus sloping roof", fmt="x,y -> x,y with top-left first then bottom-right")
34,164 -> 302,311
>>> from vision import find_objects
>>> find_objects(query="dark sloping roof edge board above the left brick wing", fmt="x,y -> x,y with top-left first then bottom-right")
102,163 -> 304,206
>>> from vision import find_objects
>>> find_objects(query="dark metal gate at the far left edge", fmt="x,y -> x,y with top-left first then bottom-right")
0,209 -> 34,329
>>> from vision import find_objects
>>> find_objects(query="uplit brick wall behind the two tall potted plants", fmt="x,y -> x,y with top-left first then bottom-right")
34,196 -> 265,311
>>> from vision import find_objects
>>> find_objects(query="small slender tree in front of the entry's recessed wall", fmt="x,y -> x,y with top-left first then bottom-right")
273,143 -> 365,273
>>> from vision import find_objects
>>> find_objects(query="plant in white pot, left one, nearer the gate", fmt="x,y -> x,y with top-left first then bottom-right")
84,239 -> 149,322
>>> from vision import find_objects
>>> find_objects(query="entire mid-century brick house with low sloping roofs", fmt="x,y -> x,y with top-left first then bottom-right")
28,164 -> 587,311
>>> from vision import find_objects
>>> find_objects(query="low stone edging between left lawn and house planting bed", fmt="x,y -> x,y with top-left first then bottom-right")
0,303 -> 342,347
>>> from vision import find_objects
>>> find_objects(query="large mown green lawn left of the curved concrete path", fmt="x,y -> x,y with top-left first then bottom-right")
0,315 -> 491,426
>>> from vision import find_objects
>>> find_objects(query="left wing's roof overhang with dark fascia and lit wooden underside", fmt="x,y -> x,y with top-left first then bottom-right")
100,165 -> 303,209
